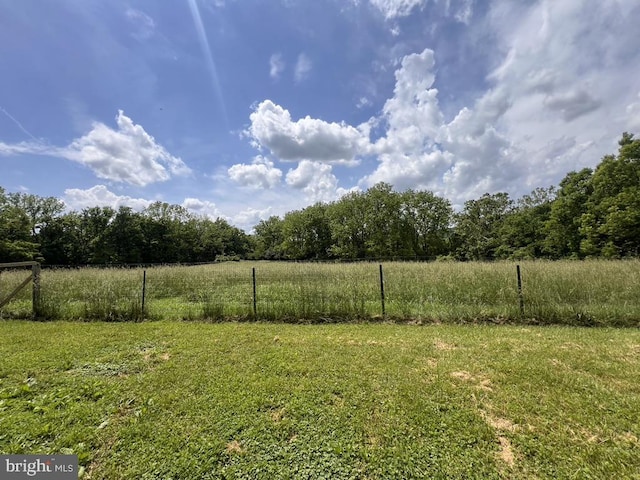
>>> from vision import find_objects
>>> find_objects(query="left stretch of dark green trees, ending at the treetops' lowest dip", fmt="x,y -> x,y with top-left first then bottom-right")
0,192 -> 251,265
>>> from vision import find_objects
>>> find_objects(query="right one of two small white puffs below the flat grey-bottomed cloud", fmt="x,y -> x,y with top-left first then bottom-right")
286,160 -> 338,202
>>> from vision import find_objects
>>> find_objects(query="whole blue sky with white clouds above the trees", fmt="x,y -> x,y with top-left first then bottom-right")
0,0 -> 640,231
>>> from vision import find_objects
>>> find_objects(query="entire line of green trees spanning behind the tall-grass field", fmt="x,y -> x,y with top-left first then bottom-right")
0,132 -> 640,265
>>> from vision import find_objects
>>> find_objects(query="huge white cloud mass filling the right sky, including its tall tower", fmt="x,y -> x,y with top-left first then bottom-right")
361,0 -> 640,204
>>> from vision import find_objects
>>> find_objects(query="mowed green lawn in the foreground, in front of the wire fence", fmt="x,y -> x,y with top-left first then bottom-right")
0,321 -> 640,479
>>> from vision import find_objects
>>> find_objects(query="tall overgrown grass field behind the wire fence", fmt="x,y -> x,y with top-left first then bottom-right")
0,260 -> 640,326
